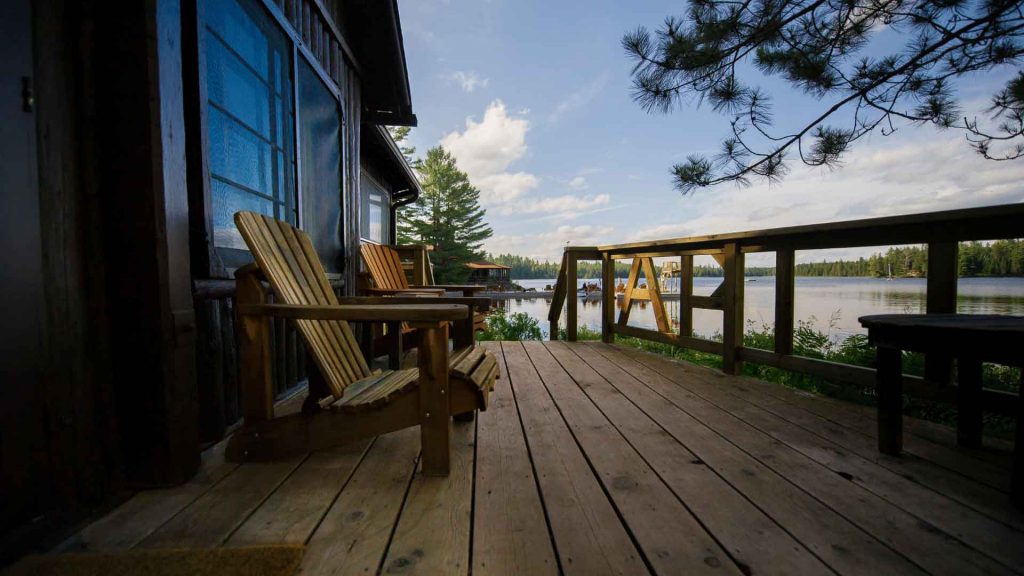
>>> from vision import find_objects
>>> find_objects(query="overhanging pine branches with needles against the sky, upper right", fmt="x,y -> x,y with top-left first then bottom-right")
623,0 -> 1024,194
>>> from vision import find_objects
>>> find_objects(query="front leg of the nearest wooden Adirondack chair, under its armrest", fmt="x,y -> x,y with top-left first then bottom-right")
413,322 -> 452,476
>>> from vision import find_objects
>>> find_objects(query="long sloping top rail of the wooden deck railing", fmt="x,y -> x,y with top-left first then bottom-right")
581,203 -> 1024,254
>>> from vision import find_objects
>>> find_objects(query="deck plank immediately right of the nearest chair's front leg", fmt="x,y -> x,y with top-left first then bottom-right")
472,342 -> 558,576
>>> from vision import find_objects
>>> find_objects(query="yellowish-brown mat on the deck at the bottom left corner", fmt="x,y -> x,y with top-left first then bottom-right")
3,546 -> 304,576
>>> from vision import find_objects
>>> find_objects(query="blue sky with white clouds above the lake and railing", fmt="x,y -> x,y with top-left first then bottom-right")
398,0 -> 1024,265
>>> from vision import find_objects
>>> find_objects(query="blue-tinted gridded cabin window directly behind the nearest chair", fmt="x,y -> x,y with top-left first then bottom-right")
204,0 -> 297,260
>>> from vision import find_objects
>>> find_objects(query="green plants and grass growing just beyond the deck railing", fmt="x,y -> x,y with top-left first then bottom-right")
558,317 -> 1021,438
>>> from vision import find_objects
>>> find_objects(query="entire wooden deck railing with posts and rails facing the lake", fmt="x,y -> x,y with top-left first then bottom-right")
548,204 -> 1024,414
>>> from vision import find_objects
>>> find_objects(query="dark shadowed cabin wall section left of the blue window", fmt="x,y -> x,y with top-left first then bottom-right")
0,0 -> 199,564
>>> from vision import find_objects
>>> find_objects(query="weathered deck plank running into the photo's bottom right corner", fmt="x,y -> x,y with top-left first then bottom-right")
606,342 -> 1012,574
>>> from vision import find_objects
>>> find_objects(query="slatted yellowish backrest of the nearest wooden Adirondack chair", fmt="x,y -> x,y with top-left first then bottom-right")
234,212 -> 370,398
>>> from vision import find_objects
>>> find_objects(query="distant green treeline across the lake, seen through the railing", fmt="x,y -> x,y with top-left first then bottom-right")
490,240 -> 1024,280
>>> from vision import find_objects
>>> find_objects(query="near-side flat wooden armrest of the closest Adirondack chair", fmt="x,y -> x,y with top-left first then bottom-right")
237,298 -> 469,322
